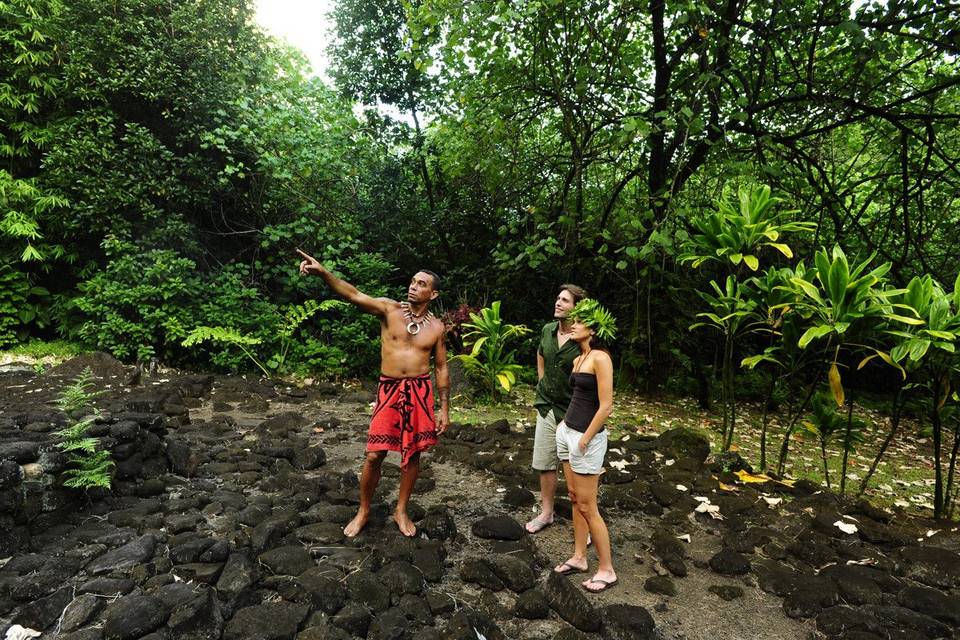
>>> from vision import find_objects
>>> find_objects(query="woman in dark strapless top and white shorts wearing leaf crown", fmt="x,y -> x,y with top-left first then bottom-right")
554,298 -> 617,593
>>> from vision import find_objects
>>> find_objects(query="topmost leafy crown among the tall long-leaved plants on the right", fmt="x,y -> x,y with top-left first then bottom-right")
680,185 -> 816,271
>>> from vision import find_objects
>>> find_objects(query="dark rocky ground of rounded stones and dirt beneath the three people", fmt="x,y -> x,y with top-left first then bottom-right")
0,358 -> 960,640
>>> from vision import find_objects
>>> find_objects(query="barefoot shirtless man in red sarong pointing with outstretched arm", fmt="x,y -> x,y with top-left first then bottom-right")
297,249 -> 450,537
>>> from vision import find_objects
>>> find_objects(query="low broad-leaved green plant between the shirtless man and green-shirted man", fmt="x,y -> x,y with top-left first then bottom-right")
453,300 -> 530,394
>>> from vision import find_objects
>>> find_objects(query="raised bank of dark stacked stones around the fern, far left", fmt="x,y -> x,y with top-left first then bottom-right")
0,360 -> 213,556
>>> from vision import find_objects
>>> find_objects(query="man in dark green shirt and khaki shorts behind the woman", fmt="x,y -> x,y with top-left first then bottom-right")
526,284 -> 587,533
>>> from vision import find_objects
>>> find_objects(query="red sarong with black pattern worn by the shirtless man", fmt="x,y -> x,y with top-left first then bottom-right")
367,374 -> 437,469
